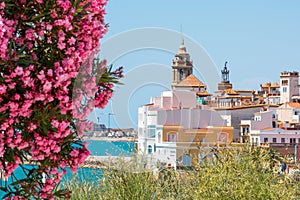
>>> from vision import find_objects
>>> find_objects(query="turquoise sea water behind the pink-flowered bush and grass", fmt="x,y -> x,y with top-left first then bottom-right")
0,140 -> 134,199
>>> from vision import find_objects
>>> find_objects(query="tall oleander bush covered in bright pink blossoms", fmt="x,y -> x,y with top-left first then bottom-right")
0,0 -> 122,199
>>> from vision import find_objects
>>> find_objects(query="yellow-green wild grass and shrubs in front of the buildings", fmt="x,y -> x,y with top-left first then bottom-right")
64,147 -> 300,200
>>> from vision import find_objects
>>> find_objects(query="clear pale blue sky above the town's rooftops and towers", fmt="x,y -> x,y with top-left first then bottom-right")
88,0 -> 300,127
